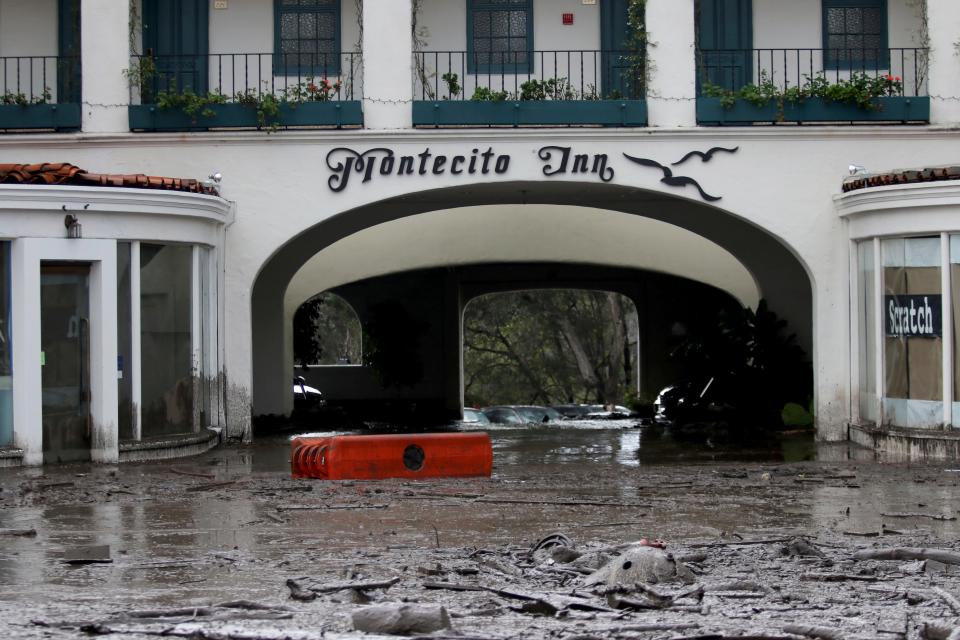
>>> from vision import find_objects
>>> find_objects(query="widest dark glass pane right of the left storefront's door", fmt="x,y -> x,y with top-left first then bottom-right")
140,244 -> 194,438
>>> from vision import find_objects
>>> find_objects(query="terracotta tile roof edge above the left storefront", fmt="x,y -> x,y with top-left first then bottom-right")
0,162 -> 218,196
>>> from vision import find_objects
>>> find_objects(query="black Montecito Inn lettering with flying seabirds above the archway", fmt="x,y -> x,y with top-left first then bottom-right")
327,145 -> 739,202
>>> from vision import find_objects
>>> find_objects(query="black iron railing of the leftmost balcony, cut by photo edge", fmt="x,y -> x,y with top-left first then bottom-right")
0,56 -> 80,106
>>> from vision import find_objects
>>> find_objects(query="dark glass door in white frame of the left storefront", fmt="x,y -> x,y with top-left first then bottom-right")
40,262 -> 92,463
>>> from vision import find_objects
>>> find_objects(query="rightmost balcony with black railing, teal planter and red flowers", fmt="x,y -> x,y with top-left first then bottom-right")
697,48 -> 930,126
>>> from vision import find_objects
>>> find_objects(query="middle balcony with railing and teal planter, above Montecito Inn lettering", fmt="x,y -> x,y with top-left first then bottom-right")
413,50 -> 647,127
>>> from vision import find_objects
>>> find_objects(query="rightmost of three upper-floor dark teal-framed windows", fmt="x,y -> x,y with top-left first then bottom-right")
823,0 -> 888,69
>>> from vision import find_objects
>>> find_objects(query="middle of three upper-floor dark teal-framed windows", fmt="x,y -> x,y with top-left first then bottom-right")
467,0 -> 533,73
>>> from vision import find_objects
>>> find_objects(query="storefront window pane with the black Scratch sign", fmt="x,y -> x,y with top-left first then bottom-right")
882,236 -> 943,427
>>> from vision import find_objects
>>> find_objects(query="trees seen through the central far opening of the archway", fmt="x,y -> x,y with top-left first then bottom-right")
464,290 -> 637,406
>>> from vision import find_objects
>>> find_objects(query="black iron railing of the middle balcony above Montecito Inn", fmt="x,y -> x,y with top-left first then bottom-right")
413,50 -> 645,101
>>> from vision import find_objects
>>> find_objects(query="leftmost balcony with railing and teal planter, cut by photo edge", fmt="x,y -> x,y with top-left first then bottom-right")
0,56 -> 80,132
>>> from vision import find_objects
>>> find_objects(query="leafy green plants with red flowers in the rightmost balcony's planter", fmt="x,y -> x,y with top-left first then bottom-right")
702,72 -> 903,120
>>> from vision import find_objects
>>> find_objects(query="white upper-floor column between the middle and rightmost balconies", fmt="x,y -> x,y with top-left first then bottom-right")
647,0 -> 697,127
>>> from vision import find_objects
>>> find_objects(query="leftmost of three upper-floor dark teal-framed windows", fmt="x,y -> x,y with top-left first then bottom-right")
273,0 -> 340,77
